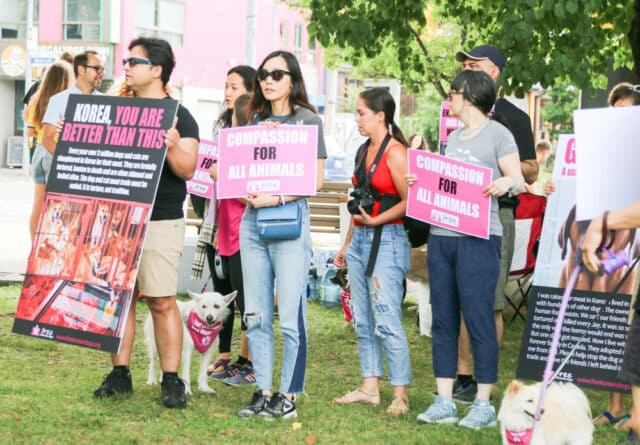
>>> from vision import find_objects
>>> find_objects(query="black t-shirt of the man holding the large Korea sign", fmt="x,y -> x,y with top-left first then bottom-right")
151,99 -> 200,221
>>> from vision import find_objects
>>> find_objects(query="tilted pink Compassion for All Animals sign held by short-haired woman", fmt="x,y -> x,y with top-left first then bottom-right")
407,149 -> 492,239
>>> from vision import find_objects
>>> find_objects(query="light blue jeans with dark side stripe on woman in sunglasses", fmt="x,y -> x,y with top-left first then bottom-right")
240,199 -> 312,393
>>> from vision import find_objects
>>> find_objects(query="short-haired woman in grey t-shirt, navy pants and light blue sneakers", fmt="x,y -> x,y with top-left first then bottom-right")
407,70 -> 525,429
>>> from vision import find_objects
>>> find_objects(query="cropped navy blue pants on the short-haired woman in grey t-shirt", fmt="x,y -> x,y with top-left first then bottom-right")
427,235 -> 501,383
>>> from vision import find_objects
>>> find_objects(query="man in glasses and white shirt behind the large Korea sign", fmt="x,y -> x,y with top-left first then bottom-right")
42,51 -> 105,155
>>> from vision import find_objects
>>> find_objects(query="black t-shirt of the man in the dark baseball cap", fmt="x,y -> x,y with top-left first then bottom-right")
493,97 -> 536,208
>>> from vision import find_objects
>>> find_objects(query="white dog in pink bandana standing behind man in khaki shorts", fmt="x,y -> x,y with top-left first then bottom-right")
144,291 -> 238,395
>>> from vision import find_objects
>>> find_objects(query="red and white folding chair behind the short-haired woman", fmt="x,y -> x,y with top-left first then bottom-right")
504,193 -> 547,321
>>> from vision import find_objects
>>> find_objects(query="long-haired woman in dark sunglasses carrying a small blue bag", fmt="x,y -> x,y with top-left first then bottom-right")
238,51 -> 327,419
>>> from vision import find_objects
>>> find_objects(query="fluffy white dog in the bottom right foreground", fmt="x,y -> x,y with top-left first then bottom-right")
498,380 -> 593,445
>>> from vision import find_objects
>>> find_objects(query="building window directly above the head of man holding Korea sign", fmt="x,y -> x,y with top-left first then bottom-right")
136,0 -> 184,48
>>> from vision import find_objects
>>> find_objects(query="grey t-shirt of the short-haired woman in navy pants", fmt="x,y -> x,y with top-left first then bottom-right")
431,120 -> 518,236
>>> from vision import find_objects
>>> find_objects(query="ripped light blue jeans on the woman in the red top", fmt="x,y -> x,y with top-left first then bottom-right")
347,224 -> 411,386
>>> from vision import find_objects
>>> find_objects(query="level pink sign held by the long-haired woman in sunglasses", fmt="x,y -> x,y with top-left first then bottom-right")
217,125 -> 318,199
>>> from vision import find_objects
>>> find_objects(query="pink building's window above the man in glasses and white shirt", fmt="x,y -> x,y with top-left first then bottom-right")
62,0 -> 102,42
